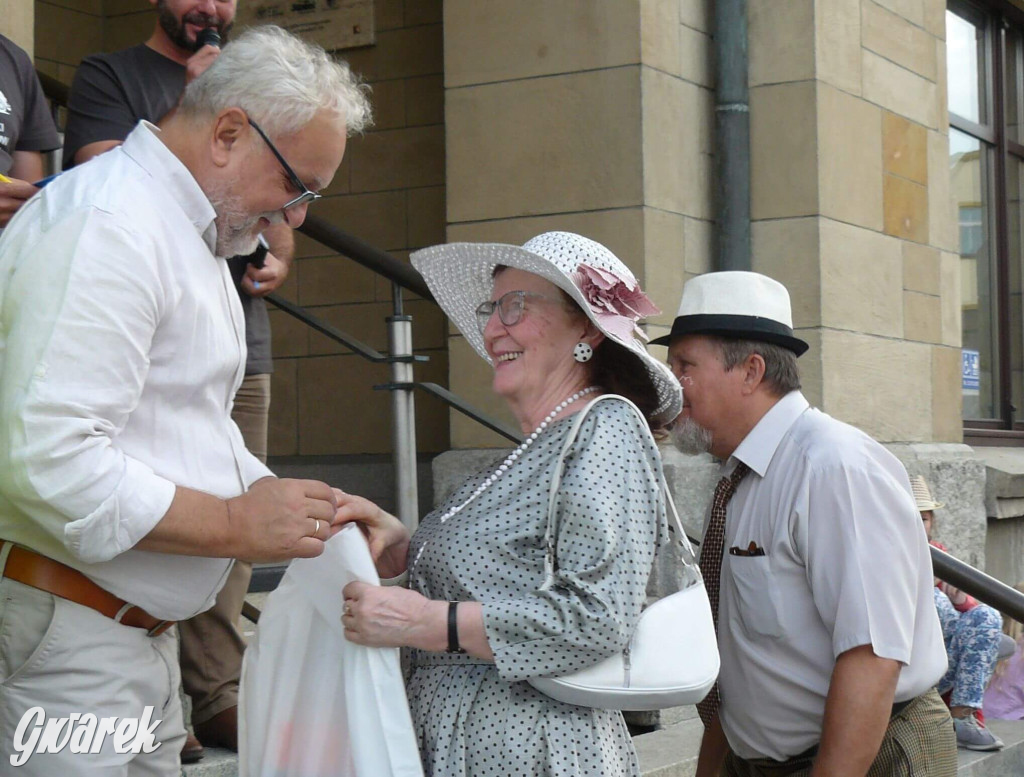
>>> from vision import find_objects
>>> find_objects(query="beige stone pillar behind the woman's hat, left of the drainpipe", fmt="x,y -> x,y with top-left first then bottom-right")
444,0 -> 712,447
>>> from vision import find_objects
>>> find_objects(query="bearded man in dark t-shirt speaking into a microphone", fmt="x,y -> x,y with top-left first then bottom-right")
63,0 -> 295,762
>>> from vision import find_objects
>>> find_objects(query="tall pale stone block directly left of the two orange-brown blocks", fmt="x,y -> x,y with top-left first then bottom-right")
817,84 -> 883,230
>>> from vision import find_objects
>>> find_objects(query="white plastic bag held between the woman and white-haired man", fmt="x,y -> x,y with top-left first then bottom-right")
239,525 -> 423,777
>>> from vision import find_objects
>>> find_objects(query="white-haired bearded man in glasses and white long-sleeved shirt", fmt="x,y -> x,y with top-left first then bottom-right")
0,28 -> 369,776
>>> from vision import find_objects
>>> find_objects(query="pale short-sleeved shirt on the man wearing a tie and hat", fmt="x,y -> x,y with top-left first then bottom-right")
719,391 -> 946,761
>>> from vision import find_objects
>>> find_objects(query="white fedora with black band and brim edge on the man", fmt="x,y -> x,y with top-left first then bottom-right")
651,270 -> 808,356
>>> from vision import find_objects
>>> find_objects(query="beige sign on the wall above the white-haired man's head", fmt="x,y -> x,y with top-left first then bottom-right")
236,0 -> 377,51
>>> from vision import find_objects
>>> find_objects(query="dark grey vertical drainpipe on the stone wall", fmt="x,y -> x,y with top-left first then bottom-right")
713,0 -> 751,270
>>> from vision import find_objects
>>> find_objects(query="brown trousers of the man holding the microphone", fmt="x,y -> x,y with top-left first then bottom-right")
178,375 -> 270,725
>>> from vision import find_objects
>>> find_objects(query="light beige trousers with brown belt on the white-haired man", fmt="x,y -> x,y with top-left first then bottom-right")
0,546 -> 185,777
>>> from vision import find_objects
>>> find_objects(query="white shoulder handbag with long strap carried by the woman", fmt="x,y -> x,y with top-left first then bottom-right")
529,394 -> 719,710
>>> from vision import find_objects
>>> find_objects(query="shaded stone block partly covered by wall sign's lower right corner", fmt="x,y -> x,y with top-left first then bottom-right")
343,25 -> 444,84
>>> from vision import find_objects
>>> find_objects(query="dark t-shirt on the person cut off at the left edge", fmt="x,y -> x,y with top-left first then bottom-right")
0,35 -> 60,173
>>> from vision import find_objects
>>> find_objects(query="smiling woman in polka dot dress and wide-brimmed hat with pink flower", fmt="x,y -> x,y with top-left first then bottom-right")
339,232 -> 682,777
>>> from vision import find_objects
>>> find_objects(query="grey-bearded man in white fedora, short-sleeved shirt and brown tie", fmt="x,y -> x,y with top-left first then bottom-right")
653,272 -> 956,777
